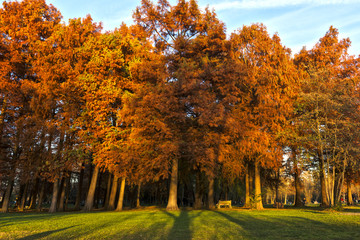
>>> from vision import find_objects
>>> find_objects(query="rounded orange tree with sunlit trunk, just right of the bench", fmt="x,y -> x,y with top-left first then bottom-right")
224,24 -> 296,209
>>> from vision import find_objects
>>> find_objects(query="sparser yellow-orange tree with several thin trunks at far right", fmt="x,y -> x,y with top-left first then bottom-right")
295,27 -> 359,207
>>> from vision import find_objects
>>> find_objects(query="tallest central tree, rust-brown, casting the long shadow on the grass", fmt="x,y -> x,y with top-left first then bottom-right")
134,0 -> 229,210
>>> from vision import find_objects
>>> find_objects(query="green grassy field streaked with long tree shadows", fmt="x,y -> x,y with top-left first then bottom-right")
0,207 -> 360,239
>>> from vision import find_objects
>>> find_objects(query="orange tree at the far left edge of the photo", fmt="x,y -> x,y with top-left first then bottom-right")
0,0 -> 61,211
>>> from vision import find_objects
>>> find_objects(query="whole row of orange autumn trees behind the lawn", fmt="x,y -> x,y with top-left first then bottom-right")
0,0 -> 360,212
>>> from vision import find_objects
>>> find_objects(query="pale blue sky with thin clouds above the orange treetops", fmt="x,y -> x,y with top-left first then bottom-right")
47,0 -> 360,55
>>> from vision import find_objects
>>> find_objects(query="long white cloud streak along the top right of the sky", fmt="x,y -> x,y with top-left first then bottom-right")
210,0 -> 360,11
